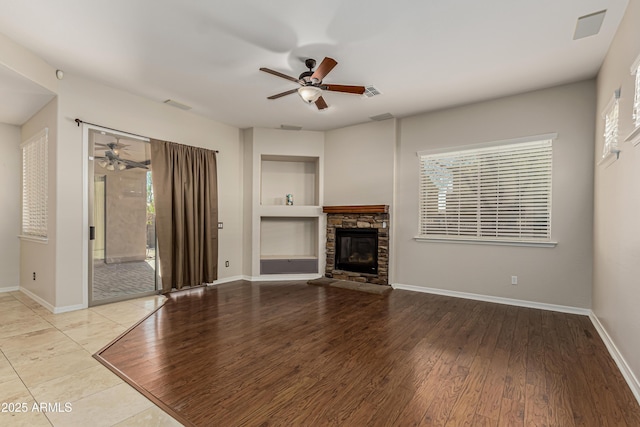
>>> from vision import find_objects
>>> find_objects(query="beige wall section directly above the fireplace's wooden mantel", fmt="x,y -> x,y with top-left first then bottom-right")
324,119 -> 396,206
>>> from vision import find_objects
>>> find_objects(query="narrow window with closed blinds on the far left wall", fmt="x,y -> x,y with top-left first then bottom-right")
20,128 -> 49,240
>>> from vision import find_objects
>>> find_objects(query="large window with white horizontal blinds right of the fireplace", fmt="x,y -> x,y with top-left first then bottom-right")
417,139 -> 552,242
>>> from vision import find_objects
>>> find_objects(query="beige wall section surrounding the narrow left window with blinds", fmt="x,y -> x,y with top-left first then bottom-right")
20,98 -> 59,308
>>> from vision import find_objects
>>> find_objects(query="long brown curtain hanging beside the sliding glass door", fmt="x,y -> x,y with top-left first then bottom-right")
151,140 -> 218,293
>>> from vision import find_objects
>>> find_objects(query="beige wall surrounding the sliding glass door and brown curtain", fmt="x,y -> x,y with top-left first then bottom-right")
55,73 -> 242,307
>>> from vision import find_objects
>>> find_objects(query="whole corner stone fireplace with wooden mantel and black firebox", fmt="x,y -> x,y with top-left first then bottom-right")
323,205 -> 389,285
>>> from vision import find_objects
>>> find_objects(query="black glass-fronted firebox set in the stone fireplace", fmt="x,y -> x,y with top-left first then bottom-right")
336,228 -> 378,274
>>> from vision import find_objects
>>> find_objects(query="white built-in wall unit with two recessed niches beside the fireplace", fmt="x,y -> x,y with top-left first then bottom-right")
243,128 -> 326,280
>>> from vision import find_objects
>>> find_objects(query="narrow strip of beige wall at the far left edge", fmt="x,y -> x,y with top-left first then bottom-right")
0,123 -> 22,292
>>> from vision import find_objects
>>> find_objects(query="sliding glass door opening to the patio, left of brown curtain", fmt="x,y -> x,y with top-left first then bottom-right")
88,128 -> 159,306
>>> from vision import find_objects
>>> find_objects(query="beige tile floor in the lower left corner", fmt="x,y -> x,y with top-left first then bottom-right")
0,292 -> 181,427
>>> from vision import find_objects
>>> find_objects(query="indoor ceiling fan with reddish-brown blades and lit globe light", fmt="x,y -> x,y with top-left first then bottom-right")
260,57 -> 364,110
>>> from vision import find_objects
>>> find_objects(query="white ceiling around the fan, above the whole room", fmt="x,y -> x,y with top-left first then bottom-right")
0,0 -> 627,130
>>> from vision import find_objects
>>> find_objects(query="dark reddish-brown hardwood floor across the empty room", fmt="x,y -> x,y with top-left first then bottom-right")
96,282 -> 640,427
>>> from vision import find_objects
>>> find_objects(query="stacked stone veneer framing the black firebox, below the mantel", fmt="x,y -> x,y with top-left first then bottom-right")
325,213 -> 389,285
